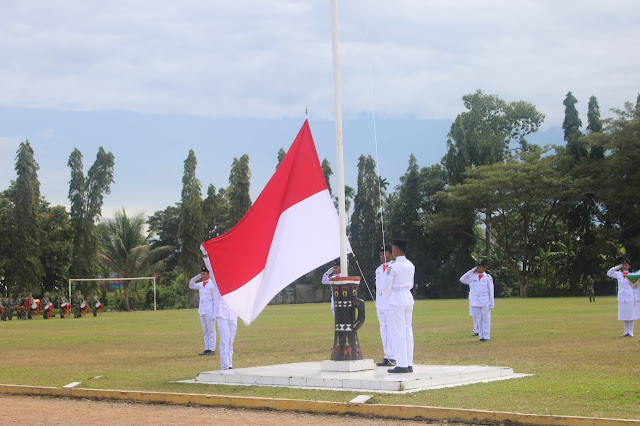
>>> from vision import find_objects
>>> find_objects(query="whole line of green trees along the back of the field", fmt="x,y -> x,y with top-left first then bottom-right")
0,90 -> 640,310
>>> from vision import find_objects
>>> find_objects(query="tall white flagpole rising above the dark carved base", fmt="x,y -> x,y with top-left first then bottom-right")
331,0 -> 349,277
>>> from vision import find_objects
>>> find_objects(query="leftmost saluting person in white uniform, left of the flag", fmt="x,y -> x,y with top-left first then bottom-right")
189,266 -> 220,356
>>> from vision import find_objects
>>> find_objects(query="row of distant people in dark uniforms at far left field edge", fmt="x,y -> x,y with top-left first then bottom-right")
0,290 -> 102,321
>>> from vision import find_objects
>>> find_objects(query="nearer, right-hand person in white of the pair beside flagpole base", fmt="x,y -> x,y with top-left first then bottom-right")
384,240 -> 416,373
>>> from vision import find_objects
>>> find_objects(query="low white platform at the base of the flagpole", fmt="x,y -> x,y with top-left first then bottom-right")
182,362 -> 528,393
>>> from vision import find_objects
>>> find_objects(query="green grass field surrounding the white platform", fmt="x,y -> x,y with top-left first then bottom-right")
0,297 -> 640,419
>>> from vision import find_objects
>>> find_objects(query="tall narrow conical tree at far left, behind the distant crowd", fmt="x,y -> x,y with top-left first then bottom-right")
5,140 -> 44,291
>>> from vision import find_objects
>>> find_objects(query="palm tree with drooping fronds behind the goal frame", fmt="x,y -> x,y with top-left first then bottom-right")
98,208 -> 173,311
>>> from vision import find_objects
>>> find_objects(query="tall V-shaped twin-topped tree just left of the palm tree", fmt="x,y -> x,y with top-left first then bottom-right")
67,147 -> 115,278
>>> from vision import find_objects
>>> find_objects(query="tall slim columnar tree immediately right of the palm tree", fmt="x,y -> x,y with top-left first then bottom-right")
178,149 -> 204,277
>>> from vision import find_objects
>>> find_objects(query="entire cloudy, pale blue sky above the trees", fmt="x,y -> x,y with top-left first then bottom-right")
0,0 -> 640,217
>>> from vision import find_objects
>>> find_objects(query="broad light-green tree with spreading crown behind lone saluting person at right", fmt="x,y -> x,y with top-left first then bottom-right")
449,149 -> 581,297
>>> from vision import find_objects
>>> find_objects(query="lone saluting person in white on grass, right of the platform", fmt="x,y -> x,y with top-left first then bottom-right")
460,260 -> 495,342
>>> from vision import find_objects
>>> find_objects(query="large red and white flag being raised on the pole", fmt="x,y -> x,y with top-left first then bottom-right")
201,121 -> 348,325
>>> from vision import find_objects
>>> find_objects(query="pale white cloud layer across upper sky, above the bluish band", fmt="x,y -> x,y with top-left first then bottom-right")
0,0 -> 640,125
